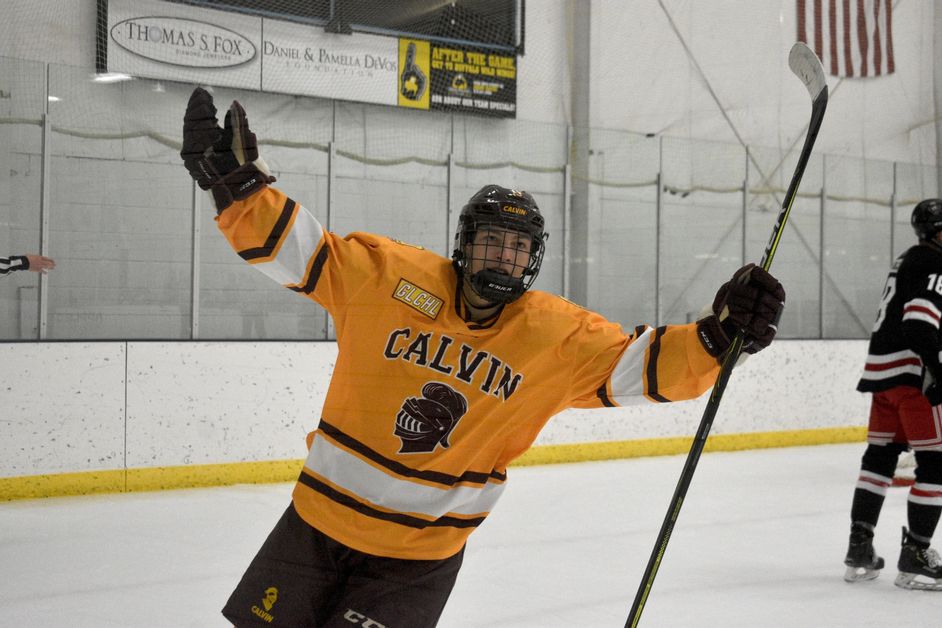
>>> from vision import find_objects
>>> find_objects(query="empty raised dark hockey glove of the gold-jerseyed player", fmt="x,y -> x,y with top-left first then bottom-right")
180,87 -> 275,214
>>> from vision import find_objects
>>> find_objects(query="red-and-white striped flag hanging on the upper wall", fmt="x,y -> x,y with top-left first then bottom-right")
796,0 -> 896,77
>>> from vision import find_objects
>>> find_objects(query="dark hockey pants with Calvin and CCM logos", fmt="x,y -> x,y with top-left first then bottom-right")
222,505 -> 464,628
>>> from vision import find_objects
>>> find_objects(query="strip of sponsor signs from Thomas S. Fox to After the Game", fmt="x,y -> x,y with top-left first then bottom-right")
99,0 -> 517,118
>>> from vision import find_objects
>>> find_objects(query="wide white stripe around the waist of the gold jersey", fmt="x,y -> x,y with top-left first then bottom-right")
304,432 -> 506,519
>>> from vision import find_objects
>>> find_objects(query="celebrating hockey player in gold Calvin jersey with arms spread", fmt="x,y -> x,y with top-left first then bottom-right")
181,88 -> 785,628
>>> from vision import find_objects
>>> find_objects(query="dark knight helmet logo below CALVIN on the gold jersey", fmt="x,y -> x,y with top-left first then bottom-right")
394,382 -> 468,454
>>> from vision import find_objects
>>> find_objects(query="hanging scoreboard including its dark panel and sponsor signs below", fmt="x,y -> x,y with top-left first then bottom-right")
96,0 -> 523,117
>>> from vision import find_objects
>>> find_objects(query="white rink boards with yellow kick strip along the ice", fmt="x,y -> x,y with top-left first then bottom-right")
0,340 -> 869,500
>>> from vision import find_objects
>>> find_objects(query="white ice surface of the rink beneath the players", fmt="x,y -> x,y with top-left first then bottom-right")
0,444 -> 942,628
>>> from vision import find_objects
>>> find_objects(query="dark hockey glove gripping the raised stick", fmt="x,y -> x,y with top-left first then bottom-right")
697,264 -> 785,358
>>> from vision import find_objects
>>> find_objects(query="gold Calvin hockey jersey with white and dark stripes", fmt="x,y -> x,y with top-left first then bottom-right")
217,188 -> 719,559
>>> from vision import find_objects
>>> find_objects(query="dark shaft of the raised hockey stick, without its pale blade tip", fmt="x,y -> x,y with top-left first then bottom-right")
625,90 -> 827,628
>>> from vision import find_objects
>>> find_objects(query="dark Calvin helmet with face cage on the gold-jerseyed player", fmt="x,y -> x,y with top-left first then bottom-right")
452,184 -> 549,303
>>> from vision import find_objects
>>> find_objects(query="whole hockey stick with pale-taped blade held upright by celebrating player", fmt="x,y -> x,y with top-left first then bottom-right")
625,42 -> 828,628
